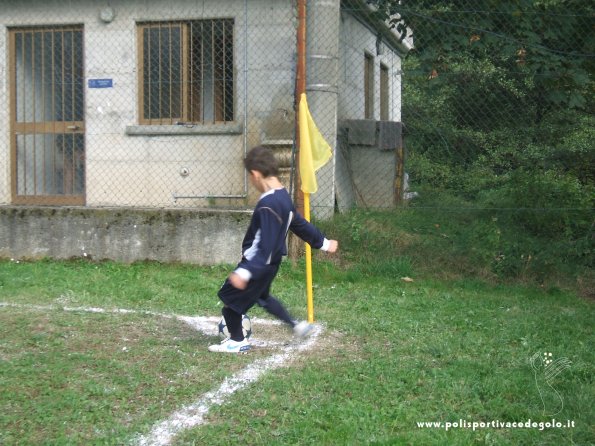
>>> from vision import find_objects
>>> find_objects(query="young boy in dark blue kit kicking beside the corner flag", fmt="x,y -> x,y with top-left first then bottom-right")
209,146 -> 338,353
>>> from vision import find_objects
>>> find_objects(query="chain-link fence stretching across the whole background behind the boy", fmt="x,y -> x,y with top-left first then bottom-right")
0,0 -> 595,240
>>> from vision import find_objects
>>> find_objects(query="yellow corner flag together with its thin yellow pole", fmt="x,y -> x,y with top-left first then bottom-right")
299,93 -> 332,323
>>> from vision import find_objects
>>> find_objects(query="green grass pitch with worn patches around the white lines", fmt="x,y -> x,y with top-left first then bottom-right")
0,209 -> 595,445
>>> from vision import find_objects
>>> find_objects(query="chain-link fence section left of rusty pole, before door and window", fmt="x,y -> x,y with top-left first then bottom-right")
0,1 -> 296,208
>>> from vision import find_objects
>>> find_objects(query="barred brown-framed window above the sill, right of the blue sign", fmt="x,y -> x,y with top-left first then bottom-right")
139,19 -> 234,124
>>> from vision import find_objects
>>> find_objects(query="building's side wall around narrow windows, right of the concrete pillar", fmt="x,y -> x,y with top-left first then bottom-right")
334,11 -> 401,210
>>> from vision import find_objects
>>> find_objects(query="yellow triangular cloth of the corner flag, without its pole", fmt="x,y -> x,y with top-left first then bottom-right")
299,93 -> 333,194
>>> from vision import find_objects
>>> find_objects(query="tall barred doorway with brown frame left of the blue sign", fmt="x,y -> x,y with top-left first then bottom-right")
9,26 -> 85,205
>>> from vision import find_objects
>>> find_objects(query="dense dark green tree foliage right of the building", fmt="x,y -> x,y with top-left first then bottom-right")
372,0 -> 595,263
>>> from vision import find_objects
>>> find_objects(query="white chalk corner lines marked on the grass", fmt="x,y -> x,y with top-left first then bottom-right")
0,302 -> 323,446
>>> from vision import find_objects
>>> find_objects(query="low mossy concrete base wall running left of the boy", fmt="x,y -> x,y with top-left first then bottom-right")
0,206 -> 251,265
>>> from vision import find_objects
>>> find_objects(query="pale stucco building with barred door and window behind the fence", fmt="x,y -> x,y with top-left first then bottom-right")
0,0 -> 412,214
